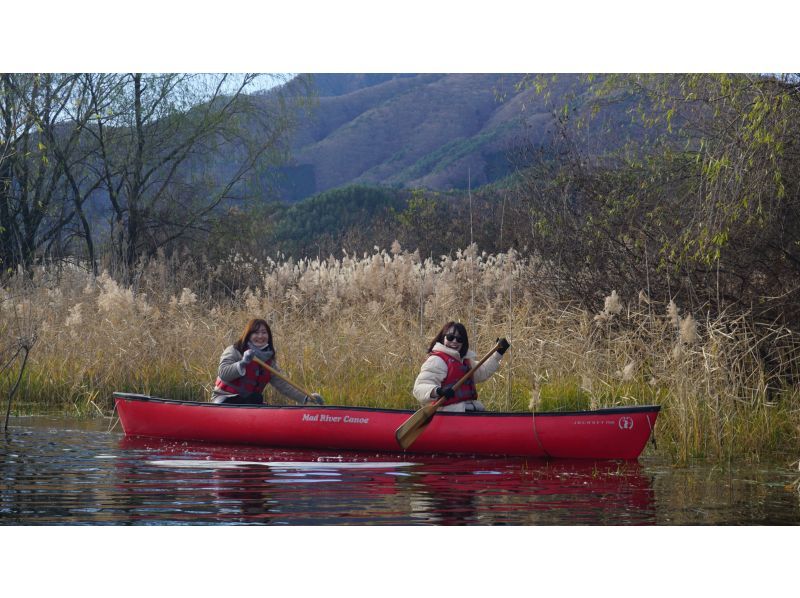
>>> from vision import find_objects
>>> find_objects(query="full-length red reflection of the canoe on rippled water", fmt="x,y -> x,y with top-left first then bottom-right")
117,437 -> 656,525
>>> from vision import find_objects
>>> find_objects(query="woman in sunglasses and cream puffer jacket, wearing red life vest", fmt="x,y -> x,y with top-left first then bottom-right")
414,321 -> 510,412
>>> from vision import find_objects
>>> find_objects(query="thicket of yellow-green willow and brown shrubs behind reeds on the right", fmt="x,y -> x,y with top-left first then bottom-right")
252,75 -> 800,332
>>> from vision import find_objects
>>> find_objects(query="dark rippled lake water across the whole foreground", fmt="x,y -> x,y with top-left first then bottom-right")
0,417 -> 800,525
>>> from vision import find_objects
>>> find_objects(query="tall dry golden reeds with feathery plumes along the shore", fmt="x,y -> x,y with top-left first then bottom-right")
0,241 -> 800,462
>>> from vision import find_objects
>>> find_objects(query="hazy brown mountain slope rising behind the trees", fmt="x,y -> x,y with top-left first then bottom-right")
270,74 -> 578,199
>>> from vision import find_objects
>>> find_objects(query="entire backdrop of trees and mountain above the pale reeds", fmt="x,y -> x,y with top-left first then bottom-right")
0,74 -> 800,332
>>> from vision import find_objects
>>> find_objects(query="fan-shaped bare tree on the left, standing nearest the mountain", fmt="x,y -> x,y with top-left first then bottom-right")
82,73 -> 295,279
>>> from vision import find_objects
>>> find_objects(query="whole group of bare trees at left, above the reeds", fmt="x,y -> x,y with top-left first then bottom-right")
0,73 -> 307,281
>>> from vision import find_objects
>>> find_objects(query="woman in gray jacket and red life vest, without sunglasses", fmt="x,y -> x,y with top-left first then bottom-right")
212,318 -> 325,405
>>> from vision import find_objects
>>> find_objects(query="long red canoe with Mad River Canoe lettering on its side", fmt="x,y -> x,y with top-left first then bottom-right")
114,393 -> 660,459
